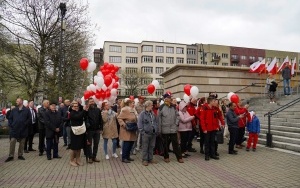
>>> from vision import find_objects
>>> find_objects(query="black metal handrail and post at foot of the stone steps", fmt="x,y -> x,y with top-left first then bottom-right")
264,97 -> 300,147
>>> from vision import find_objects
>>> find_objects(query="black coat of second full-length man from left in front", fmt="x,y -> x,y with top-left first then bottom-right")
44,110 -> 63,138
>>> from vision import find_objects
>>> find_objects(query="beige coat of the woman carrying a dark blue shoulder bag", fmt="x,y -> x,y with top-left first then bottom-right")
118,106 -> 137,141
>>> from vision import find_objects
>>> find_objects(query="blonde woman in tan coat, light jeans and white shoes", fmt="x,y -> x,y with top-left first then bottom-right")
101,102 -> 118,159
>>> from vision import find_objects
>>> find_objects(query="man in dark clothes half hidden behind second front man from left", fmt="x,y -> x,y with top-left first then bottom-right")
37,100 -> 49,156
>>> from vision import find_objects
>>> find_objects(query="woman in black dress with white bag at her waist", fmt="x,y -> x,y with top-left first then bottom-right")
70,101 -> 86,166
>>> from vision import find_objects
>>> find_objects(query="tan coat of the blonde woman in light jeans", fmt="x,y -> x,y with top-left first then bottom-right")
101,110 -> 118,139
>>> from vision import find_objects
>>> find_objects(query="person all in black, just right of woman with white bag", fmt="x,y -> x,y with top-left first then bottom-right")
85,98 -> 103,163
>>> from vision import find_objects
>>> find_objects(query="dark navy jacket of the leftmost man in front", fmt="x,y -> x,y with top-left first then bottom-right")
8,106 -> 32,138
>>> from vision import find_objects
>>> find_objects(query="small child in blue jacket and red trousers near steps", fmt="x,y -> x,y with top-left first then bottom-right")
246,111 -> 260,151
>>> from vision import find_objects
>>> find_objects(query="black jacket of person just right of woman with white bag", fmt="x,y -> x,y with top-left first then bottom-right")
85,107 -> 103,131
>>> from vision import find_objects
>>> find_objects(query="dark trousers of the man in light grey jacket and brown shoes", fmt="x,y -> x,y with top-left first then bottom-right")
162,133 -> 182,160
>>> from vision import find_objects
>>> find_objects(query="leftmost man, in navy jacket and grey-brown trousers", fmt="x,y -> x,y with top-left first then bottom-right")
5,98 -> 31,162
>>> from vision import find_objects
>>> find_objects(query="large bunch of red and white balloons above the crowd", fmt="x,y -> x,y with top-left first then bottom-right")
80,58 -> 120,106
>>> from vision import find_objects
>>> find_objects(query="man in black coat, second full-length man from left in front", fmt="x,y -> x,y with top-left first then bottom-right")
44,102 -> 63,160
